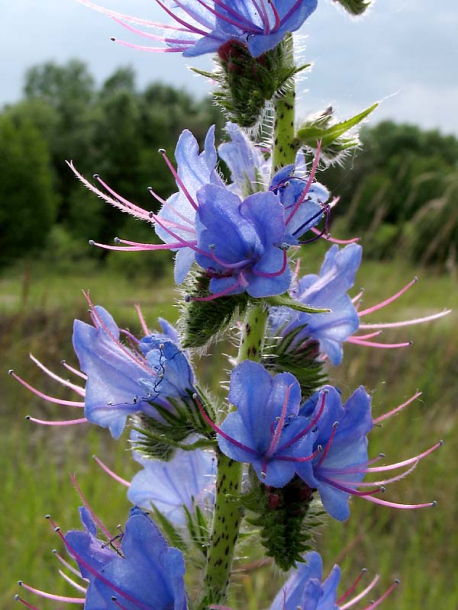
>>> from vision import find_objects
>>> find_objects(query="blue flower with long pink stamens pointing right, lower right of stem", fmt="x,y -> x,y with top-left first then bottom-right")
296,386 -> 442,521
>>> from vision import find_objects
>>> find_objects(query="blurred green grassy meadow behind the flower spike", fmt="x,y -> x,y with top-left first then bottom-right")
0,254 -> 458,610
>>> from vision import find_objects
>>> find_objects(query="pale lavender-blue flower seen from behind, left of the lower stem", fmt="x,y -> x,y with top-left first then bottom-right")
127,440 -> 216,526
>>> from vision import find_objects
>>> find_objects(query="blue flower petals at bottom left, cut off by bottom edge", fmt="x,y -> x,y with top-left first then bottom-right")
63,507 -> 187,610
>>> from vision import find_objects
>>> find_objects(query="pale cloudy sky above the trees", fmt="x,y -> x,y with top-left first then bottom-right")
0,0 -> 458,135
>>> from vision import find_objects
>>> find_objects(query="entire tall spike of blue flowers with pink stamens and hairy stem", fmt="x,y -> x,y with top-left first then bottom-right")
10,0 -> 448,610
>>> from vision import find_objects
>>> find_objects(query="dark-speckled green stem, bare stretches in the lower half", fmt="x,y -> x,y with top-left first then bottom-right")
198,302 -> 268,610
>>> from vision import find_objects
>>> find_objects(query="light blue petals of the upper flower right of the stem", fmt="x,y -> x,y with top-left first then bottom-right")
269,244 -> 362,365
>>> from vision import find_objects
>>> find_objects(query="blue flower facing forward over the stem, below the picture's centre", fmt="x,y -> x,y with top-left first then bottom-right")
218,360 -> 313,487
